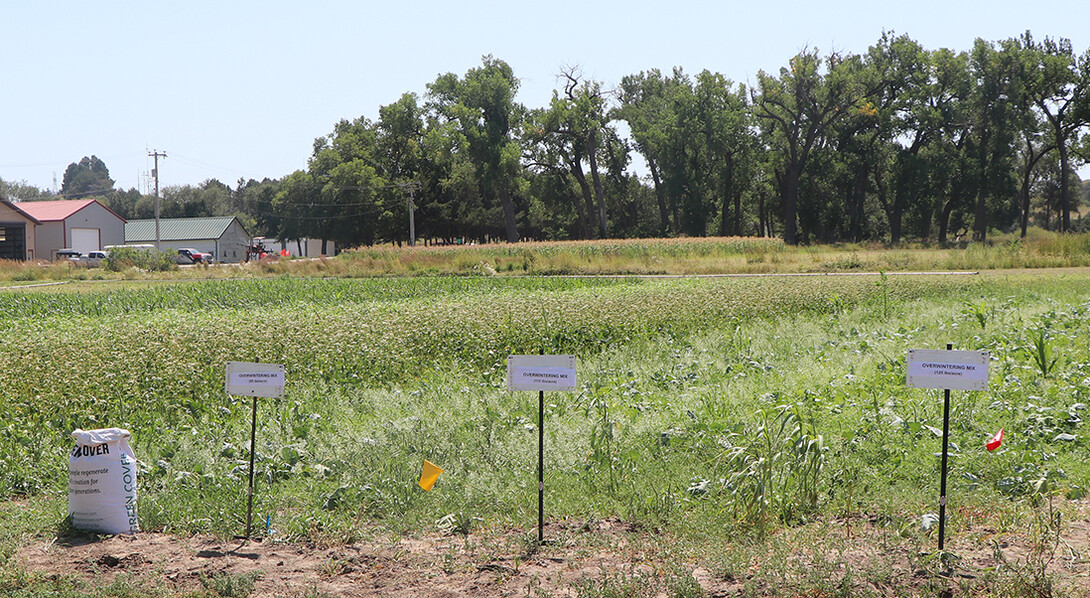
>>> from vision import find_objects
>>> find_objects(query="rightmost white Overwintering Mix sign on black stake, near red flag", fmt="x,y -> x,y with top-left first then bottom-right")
907,343 -> 990,550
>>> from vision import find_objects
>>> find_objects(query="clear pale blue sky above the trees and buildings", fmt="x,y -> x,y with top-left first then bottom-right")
0,0 -> 1090,191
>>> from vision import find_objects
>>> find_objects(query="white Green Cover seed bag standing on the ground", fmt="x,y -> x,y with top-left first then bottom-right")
69,428 -> 140,534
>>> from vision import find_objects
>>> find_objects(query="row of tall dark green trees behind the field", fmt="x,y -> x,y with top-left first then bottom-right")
0,32 -> 1090,246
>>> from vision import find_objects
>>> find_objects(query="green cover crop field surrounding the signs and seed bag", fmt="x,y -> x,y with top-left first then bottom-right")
0,269 -> 1090,596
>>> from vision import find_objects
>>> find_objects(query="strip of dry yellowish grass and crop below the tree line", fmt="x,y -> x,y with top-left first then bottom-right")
6,230 -> 1090,285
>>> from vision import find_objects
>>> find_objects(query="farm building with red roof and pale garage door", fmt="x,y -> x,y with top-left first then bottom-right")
19,199 -> 125,259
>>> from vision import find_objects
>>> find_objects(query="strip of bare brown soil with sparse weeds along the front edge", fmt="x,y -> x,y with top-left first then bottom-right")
15,501 -> 1090,598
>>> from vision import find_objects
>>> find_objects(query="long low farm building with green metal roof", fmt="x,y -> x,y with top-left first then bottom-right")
125,216 -> 250,263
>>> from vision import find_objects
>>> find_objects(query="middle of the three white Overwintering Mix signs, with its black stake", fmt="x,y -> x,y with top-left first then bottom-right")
507,355 -> 576,545
